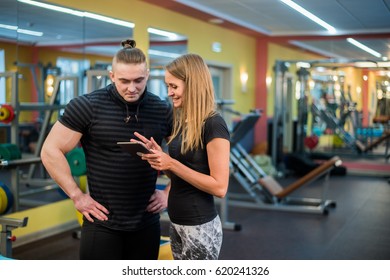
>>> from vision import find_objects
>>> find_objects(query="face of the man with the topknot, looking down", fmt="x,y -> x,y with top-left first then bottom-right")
110,63 -> 149,102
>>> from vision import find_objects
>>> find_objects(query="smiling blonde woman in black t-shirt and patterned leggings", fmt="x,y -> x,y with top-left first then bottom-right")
135,54 -> 230,260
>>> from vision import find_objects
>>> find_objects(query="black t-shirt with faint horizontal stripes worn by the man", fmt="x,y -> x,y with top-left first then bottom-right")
59,85 -> 172,231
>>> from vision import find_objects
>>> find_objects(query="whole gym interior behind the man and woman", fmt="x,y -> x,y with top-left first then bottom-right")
0,0 -> 390,260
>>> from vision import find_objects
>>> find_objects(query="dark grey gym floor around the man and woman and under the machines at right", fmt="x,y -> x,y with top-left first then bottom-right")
13,166 -> 390,260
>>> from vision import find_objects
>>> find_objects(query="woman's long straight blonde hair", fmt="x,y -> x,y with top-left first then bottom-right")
165,54 -> 216,154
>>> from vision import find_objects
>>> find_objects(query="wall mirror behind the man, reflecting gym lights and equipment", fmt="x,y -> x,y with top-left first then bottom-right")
0,0 -> 187,211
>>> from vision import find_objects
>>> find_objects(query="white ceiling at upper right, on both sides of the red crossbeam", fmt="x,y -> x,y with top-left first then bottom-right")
165,0 -> 390,59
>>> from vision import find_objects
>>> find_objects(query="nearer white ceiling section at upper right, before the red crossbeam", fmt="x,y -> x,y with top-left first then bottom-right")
175,0 -> 390,36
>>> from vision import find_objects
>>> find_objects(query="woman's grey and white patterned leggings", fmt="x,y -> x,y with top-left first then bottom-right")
170,216 -> 223,260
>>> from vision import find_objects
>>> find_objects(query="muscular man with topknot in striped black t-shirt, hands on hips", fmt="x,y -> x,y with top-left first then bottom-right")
41,41 -> 172,260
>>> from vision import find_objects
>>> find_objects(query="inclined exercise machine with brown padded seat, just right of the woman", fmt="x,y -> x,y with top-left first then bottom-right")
225,111 -> 341,214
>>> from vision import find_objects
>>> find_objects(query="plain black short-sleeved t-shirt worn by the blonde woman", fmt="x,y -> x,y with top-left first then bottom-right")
168,114 -> 230,225
